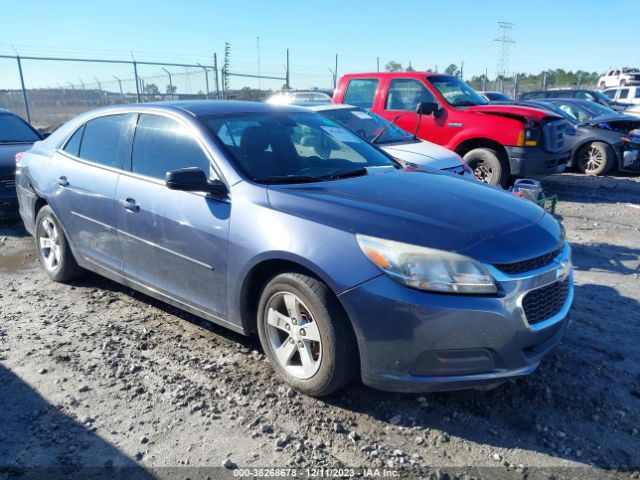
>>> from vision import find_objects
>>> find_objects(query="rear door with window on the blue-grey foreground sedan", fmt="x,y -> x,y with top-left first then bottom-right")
49,114 -> 133,272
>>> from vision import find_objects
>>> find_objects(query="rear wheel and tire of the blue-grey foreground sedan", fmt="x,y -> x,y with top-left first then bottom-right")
36,205 -> 83,282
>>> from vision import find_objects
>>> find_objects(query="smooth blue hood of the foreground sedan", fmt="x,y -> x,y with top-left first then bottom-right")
268,170 -> 561,263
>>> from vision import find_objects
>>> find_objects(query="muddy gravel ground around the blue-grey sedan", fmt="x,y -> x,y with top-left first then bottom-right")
0,174 -> 640,479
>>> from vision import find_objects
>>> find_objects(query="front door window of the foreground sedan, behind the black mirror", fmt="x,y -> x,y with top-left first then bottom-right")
131,114 -> 211,181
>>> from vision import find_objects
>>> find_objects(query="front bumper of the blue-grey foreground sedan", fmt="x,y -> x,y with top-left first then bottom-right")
340,245 -> 573,392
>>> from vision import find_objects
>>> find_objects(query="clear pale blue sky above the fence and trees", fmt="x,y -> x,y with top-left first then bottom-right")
0,0 -> 640,91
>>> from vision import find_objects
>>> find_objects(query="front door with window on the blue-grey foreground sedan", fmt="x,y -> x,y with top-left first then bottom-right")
116,113 -> 231,317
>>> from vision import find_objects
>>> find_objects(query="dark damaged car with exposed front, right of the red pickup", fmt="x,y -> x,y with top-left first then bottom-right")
530,98 -> 640,175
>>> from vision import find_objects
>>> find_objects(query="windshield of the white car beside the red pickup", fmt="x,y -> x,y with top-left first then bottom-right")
318,107 -> 415,144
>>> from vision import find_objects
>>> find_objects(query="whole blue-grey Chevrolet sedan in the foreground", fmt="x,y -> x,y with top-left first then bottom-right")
17,101 -> 573,396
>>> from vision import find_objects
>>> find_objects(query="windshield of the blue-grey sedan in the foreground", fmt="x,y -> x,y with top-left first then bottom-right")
202,111 -> 400,183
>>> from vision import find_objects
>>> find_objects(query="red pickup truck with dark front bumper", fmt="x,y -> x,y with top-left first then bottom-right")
333,72 -> 570,186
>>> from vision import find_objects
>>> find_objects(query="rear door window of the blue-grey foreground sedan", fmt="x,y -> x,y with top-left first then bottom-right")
77,114 -> 129,168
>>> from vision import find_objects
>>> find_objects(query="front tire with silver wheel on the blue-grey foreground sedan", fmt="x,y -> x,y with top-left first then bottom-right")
258,272 -> 359,397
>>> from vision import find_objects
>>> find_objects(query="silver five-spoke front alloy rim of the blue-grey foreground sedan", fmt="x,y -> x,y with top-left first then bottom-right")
265,292 -> 322,380
